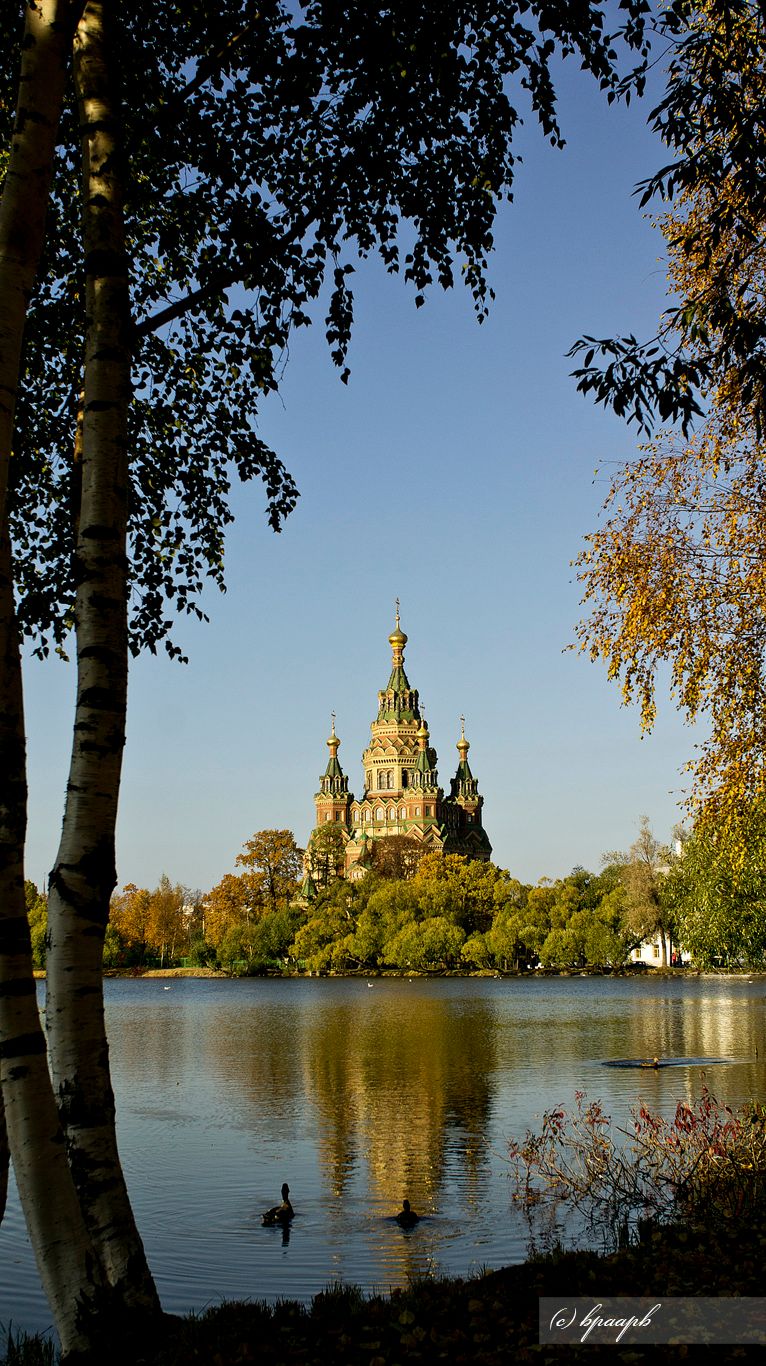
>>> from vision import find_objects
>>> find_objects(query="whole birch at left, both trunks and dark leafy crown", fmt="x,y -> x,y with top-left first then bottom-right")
0,0 -> 658,1352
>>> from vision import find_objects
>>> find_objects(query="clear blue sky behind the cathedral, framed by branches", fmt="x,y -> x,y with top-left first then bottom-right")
26,58 -> 694,889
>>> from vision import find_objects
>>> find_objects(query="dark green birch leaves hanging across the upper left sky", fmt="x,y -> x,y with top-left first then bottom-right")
0,0 -> 650,653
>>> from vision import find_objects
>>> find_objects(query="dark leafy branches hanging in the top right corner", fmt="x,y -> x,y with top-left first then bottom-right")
569,0 -> 766,436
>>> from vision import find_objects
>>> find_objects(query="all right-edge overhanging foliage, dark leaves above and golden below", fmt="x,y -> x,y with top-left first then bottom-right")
578,0 -> 766,843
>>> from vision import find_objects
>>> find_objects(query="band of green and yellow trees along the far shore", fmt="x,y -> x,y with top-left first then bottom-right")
27,818 -> 766,975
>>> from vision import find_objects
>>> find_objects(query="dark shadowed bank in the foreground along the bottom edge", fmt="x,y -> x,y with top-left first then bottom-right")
5,1210 -> 766,1366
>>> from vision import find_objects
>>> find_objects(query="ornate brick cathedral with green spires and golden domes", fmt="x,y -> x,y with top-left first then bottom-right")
308,601 -> 492,878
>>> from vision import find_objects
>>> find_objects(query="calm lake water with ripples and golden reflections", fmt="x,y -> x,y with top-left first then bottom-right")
0,977 -> 766,1330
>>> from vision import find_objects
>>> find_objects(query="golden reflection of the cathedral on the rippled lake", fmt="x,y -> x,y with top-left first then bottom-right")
303,982 -> 496,1245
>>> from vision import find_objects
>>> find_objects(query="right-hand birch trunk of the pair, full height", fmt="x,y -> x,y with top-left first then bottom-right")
46,0 -> 160,1314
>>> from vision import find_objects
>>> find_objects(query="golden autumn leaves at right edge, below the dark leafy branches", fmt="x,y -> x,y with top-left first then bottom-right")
578,404 -> 766,829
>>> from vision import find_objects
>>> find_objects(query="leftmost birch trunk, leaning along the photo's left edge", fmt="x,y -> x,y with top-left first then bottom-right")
0,0 -> 101,1355
